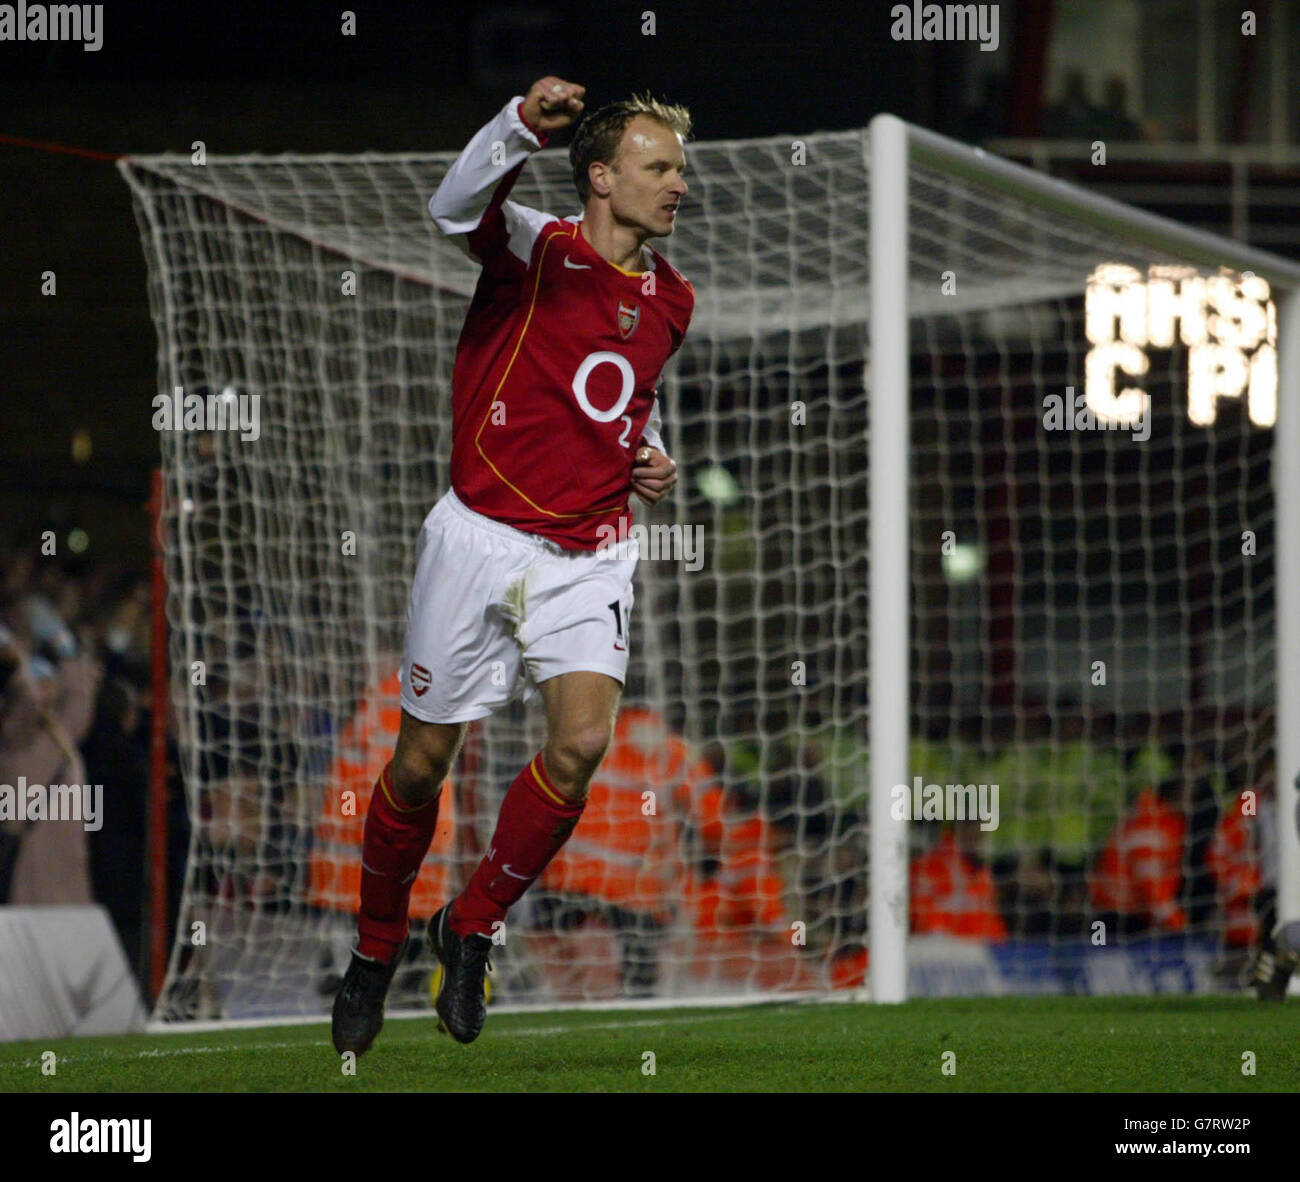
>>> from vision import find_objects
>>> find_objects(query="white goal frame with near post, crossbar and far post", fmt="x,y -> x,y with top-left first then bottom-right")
868,114 -> 1300,1003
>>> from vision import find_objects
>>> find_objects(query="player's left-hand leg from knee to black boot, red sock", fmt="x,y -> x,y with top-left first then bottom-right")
333,710 -> 465,1055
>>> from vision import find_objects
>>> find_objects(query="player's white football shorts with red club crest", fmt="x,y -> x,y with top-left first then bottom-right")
400,492 -> 638,723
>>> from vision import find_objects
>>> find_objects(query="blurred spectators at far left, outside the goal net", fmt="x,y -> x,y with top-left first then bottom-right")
0,544 -> 161,970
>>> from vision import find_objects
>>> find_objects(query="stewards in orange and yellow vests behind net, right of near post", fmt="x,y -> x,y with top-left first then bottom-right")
911,741 -> 1275,952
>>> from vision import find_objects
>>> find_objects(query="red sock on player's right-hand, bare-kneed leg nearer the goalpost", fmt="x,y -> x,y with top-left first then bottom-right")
451,755 -> 585,936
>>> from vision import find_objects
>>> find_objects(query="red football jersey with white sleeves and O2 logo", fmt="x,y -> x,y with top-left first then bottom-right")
430,99 -> 696,550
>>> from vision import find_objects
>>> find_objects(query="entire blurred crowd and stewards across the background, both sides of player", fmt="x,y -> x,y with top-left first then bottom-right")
0,545 -> 1274,993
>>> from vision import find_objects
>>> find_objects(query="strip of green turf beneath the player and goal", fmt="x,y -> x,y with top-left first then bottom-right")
0,996 -> 1300,1092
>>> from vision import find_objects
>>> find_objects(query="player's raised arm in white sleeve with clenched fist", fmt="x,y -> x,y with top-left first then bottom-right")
429,77 -> 585,263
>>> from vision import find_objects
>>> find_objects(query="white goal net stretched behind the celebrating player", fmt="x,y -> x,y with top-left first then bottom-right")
121,115 -> 1296,1021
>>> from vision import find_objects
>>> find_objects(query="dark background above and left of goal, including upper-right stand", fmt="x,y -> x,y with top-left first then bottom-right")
0,0 -> 1300,566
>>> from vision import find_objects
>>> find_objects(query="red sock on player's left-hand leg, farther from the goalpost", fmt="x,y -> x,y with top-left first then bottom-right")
356,763 -> 439,964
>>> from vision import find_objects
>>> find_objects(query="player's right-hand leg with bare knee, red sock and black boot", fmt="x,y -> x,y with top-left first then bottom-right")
429,670 -> 623,1043
